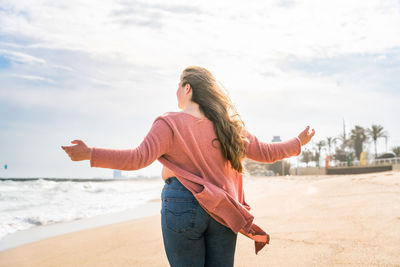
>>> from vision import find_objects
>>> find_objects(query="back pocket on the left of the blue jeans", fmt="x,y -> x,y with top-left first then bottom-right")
164,197 -> 198,233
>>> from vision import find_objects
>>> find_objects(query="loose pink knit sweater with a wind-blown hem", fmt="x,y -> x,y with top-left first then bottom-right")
90,112 -> 301,254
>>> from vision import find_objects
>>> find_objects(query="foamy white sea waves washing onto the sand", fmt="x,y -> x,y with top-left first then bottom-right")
0,177 -> 164,241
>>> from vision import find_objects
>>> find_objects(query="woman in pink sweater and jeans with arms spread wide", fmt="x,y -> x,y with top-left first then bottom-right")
62,66 -> 315,267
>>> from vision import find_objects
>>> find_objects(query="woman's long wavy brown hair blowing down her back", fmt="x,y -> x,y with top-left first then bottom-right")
181,66 -> 246,173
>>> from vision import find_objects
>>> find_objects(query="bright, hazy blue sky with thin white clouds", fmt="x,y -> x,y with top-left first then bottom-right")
0,0 -> 400,178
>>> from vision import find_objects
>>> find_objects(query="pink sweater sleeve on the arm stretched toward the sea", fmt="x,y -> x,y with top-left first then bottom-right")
90,118 -> 173,170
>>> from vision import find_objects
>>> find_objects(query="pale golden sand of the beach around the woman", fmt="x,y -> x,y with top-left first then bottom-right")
0,171 -> 400,267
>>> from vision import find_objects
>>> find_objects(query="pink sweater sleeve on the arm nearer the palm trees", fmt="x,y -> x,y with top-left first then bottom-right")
245,131 -> 301,163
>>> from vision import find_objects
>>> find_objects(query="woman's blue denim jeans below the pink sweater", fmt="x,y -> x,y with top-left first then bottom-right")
161,177 -> 237,267
